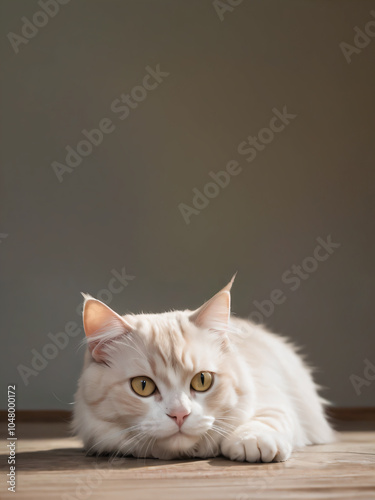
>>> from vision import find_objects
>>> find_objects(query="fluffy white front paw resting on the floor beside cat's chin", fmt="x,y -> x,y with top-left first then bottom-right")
221,431 -> 292,462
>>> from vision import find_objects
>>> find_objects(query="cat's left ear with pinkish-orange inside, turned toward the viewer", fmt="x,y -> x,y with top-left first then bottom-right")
82,294 -> 132,362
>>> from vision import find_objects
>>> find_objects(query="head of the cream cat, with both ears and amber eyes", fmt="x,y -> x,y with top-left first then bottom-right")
76,279 -> 248,458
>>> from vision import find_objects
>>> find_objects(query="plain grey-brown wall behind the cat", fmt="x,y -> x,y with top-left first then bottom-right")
0,0 -> 375,409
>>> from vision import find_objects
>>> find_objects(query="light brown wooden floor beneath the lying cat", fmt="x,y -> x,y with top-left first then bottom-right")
0,423 -> 375,500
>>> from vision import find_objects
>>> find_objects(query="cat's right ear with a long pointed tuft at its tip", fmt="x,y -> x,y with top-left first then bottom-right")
190,273 -> 237,331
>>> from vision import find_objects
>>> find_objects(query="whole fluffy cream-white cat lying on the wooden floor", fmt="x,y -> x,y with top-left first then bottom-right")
73,277 -> 334,462
